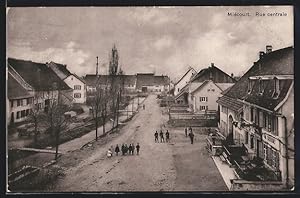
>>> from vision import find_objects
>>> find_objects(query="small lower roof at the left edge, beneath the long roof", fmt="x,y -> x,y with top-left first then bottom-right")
7,73 -> 33,100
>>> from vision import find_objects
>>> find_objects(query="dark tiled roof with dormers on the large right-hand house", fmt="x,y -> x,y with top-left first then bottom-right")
224,47 -> 294,110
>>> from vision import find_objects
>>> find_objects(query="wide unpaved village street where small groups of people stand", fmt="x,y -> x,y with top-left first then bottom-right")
48,95 -> 227,192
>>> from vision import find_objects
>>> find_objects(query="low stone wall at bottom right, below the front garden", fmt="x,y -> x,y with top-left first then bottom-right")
230,179 -> 284,191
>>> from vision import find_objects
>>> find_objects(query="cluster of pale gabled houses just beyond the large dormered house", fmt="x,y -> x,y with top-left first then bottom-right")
174,63 -> 236,113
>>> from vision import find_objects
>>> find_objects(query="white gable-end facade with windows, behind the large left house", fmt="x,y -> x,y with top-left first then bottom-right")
64,75 -> 86,103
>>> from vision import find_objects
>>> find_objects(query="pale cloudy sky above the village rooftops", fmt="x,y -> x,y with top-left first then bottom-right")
7,6 -> 294,79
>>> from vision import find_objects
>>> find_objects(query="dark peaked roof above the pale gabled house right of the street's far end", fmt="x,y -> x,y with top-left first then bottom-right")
191,66 -> 236,83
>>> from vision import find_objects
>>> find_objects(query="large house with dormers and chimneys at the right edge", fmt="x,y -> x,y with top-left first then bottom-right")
217,46 -> 295,187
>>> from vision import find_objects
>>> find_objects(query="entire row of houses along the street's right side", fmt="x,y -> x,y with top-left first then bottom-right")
174,45 -> 295,187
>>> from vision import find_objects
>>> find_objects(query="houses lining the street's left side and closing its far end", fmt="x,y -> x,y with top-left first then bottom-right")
6,58 -> 170,124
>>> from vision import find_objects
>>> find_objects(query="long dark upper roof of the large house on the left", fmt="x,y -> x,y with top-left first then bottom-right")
8,58 -> 71,91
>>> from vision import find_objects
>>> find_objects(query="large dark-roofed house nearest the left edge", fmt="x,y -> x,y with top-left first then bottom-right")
7,58 -> 73,121
